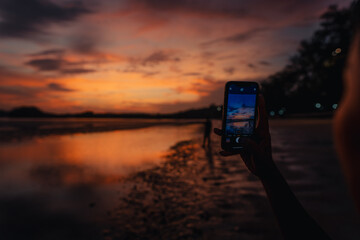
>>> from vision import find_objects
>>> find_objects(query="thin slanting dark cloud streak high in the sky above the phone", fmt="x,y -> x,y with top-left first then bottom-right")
200,28 -> 269,47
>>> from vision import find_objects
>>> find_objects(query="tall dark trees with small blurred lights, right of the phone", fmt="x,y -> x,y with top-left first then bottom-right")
262,5 -> 353,116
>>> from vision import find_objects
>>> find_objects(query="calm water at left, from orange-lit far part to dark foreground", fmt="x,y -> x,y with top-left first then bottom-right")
0,124 -> 202,239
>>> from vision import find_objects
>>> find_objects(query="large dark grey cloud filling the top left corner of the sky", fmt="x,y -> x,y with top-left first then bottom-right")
0,0 -> 90,38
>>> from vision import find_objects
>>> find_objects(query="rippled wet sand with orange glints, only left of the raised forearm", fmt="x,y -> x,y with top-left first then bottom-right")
104,141 -> 279,239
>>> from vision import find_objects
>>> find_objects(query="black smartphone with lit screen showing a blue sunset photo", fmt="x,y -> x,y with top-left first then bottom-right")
221,81 -> 259,152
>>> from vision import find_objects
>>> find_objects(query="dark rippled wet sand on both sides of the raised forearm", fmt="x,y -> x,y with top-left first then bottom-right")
100,120 -> 360,240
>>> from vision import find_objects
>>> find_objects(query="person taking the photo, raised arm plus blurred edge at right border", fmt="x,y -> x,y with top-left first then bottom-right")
214,1 -> 360,240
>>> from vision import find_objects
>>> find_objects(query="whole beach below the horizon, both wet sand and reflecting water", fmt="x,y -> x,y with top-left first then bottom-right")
0,119 -> 360,240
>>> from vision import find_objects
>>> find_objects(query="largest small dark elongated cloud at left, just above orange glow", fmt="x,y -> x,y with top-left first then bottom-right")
25,58 -> 95,74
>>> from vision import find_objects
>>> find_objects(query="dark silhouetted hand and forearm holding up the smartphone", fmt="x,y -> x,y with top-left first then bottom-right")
214,96 -> 330,240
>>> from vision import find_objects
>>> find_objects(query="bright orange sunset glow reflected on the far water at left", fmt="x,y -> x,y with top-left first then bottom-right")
0,125 -> 201,175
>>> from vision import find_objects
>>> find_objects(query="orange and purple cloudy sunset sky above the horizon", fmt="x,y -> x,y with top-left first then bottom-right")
0,0 -> 351,113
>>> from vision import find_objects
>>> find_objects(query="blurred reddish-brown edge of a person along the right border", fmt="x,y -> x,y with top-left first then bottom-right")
333,1 -> 360,213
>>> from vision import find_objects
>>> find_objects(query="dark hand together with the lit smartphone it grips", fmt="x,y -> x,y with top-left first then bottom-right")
214,82 -> 275,178
